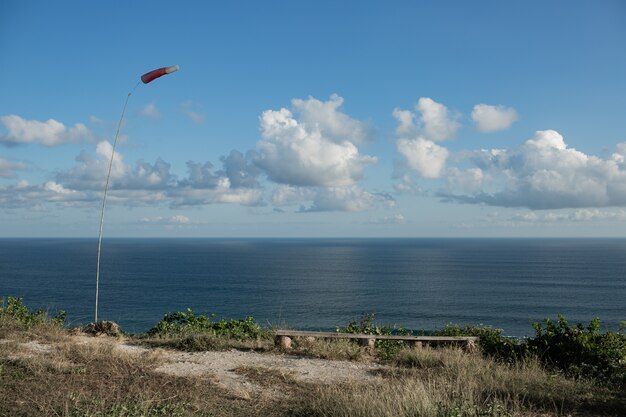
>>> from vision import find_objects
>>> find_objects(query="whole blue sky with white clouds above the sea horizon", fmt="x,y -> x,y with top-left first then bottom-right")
0,0 -> 626,237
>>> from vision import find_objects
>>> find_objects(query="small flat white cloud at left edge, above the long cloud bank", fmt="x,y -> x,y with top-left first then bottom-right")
0,115 -> 94,146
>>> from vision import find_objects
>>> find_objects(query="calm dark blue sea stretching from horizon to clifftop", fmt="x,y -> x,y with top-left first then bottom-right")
0,239 -> 626,336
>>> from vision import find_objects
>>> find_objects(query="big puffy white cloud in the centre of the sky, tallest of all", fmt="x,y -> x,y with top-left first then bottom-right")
255,95 -> 377,187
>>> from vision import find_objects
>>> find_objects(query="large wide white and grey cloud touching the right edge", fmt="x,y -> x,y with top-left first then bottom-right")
447,130 -> 626,209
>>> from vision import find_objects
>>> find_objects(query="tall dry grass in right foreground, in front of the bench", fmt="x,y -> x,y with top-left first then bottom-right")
295,349 -> 626,417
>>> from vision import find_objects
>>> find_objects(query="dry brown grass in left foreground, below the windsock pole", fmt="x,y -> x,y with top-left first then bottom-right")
0,326 -> 290,416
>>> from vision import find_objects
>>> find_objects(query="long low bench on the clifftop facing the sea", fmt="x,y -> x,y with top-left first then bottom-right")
274,330 -> 479,350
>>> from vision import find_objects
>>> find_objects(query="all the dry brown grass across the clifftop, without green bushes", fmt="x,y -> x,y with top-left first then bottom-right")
0,324 -> 626,417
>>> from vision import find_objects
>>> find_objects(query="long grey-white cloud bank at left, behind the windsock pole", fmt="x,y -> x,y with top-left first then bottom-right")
0,141 -> 264,208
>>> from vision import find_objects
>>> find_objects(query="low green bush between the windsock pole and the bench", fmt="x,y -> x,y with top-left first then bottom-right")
148,308 -> 265,340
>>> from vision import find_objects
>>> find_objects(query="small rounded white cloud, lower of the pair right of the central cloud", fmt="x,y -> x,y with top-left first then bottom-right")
396,138 -> 449,178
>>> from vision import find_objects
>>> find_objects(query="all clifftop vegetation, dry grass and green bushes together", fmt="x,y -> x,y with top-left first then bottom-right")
0,297 -> 626,417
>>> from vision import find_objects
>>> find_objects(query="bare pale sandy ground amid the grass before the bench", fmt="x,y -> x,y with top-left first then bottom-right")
13,336 -> 383,398
